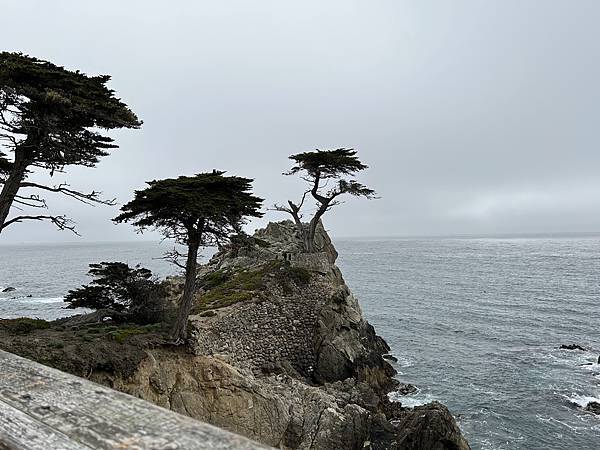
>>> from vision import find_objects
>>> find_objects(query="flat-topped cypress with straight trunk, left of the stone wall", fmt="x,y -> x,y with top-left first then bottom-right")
113,171 -> 263,342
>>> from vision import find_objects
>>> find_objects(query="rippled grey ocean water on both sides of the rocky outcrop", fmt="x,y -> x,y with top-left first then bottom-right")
0,236 -> 600,450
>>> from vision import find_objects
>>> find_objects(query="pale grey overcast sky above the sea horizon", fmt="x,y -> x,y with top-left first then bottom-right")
0,0 -> 600,242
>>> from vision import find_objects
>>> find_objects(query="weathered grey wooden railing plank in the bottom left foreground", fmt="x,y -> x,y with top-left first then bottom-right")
0,350 -> 267,450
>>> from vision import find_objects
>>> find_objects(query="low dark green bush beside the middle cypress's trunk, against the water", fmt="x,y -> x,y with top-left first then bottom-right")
65,262 -> 166,323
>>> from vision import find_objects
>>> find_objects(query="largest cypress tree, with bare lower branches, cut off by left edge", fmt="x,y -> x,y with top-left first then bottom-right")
0,52 -> 141,233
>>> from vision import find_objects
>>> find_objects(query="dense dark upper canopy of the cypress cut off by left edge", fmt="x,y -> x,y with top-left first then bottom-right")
0,52 -> 141,171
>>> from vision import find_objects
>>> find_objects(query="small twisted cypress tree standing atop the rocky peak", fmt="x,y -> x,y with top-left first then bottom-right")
275,148 -> 375,253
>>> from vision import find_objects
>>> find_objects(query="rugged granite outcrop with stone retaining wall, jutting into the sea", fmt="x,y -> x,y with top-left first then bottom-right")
97,221 -> 469,450
